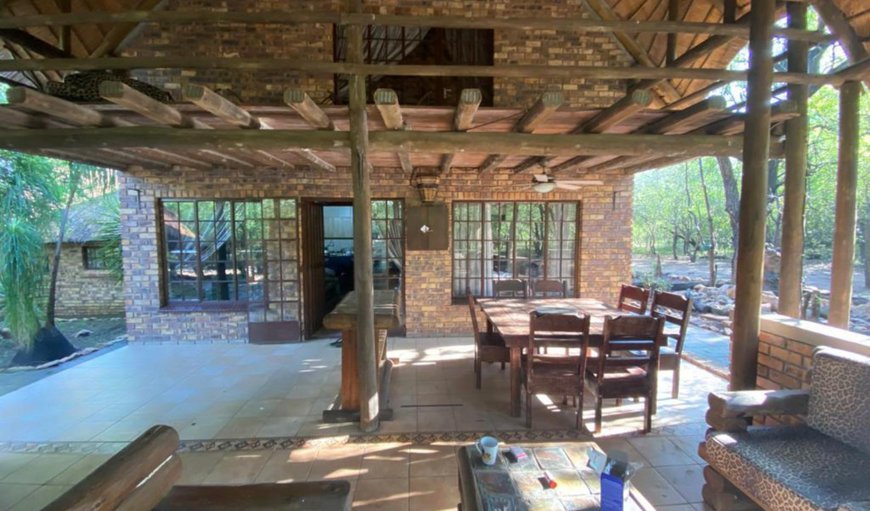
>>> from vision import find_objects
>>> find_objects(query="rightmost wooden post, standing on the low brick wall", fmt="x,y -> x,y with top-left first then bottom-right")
828,82 -> 862,328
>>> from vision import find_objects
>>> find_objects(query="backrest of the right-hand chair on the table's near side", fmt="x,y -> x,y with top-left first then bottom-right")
597,316 -> 665,383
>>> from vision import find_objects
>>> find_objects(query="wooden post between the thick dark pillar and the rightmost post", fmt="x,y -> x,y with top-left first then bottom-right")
779,2 -> 809,318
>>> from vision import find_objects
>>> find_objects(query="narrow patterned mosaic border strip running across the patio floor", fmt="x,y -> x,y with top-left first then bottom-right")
0,430 -> 594,454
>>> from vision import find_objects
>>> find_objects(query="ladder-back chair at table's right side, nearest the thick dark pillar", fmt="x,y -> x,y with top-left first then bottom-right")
650,291 -> 692,404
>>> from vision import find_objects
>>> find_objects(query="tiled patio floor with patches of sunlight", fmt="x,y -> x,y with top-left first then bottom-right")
0,339 -> 725,510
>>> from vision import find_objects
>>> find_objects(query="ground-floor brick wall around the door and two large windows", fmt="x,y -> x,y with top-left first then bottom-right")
119,168 -> 632,341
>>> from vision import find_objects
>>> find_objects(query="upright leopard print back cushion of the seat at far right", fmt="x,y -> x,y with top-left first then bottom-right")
806,348 -> 870,456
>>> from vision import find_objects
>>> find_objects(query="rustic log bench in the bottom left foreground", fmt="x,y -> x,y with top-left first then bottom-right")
43,426 -> 351,511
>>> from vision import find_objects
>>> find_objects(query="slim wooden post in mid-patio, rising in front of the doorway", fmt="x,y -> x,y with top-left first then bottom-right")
346,0 -> 378,432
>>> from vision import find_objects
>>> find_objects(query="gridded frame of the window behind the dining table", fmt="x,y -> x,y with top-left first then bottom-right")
450,200 -> 582,303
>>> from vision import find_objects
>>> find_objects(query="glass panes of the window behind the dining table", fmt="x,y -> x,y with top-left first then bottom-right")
453,202 -> 577,297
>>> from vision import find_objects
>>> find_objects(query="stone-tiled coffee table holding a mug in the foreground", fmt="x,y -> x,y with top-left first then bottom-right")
456,442 -> 655,511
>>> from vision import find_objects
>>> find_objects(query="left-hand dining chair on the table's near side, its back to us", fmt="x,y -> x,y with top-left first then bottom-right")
523,312 -> 589,429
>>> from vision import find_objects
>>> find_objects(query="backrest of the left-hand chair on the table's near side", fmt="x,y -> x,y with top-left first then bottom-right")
526,311 -> 590,378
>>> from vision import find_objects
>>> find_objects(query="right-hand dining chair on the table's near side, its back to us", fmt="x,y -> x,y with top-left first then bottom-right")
586,316 -> 664,433
